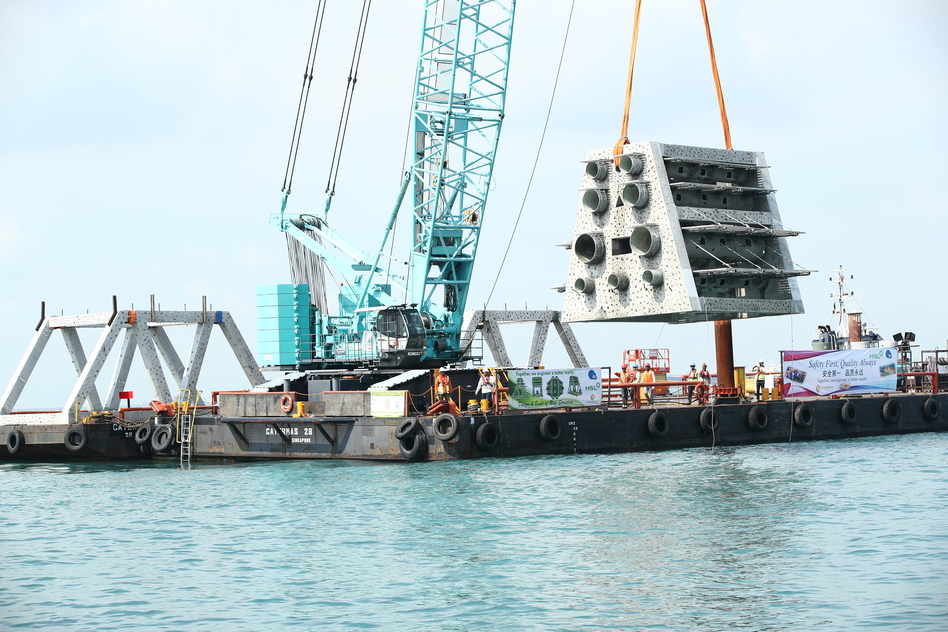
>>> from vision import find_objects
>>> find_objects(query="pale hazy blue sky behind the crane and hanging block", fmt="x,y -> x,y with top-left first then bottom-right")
0,0 -> 948,408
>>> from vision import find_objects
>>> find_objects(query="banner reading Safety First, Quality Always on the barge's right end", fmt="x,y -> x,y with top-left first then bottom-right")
783,347 -> 898,397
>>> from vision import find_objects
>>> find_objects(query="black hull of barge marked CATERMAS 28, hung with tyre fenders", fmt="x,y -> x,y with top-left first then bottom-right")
193,394 -> 948,461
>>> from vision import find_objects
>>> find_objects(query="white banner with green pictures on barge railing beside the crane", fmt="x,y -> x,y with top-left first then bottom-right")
507,368 -> 602,410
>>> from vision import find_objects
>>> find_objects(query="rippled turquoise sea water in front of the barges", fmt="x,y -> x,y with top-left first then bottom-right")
0,434 -> 948,630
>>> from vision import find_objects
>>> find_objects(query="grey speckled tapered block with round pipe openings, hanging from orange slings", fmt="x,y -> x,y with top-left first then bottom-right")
562,142 -> 810,323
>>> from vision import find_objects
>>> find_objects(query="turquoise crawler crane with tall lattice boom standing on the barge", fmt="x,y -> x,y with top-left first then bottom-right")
270,0 -> 516,369
